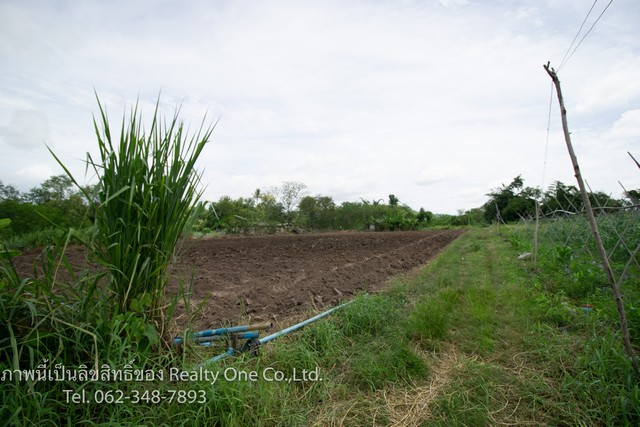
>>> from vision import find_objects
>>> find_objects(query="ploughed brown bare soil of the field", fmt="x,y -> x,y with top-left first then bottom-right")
8,230 -> 463,329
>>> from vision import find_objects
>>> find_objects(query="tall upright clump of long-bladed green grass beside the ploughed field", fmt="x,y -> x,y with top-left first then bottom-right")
55,99 -> 214,317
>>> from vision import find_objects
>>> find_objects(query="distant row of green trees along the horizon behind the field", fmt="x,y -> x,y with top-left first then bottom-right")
0,175 -> 640,239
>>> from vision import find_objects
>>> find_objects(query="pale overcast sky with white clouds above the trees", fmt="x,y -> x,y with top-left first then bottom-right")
0,0 -> 640,214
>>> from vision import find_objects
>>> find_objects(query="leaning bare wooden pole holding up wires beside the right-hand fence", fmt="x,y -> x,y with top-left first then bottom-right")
543,62 -> 640,376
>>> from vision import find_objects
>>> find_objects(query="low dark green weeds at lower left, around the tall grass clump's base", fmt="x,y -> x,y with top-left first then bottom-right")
0,247 -> 180,425
